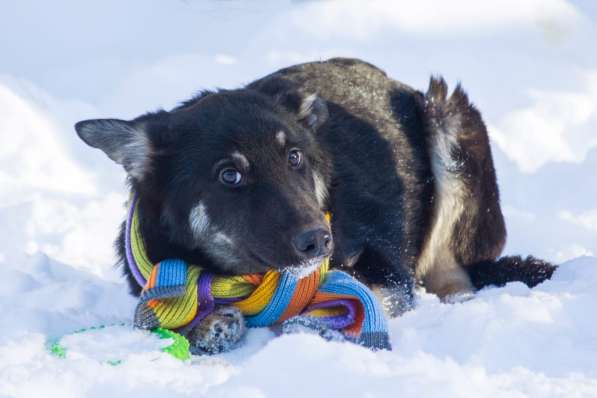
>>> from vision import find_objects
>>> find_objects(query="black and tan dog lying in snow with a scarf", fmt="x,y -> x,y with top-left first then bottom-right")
75,58 -> 555,353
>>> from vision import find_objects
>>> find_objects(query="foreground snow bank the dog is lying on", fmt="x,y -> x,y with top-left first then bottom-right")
0,255 -> 597,398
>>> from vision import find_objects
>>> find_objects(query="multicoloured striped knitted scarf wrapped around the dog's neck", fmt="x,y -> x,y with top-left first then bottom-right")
125,196 -> 391,349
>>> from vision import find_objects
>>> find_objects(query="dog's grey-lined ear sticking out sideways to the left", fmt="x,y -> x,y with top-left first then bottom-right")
75,113 -> 164,180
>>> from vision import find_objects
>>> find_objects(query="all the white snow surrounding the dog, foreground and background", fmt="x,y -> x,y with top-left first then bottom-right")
0,0 -> 597,398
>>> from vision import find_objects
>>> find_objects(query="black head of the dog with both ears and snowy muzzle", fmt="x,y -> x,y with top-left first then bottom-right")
75,89 -> 332,274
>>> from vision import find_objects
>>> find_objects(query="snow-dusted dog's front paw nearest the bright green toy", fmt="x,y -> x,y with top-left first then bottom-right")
187,306 -> 246,355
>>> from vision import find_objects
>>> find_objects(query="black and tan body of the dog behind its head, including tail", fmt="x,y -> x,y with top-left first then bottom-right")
250,58 -> 554,301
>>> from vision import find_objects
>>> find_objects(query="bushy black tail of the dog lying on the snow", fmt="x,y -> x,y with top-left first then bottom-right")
466,256 -> 557,289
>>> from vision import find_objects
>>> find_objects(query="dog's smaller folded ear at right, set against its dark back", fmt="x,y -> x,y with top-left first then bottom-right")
276,91 -> 328,130
